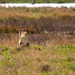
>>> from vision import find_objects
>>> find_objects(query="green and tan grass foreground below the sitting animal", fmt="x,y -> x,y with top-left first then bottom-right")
0,44 -> 75,75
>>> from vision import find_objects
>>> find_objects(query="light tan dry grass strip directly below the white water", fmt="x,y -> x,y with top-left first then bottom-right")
0,7 -> 75,18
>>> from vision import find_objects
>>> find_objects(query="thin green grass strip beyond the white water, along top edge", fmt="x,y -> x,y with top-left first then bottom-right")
0,0 -> 75,3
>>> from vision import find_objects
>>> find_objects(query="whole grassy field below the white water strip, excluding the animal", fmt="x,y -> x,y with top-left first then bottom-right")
0,7 -> 75,75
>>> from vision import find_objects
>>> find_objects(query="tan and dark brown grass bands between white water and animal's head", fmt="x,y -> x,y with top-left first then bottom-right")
0,7 -> 75,33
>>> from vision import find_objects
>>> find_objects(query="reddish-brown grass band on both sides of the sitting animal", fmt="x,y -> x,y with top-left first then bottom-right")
0,32 -> 75,47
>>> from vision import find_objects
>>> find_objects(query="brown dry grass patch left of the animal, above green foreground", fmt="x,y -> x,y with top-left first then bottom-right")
0,33 -> 19,47
